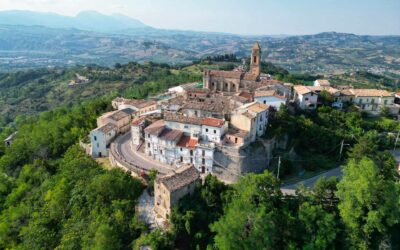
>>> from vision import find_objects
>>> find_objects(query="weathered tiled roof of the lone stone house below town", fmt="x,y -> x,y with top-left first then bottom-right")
158,165 -> 200,192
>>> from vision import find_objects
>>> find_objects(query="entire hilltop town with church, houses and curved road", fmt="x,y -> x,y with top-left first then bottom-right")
81,42 -> 400,222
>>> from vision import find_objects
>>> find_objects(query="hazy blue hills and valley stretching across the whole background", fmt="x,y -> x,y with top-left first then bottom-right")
0,22 -> 400,76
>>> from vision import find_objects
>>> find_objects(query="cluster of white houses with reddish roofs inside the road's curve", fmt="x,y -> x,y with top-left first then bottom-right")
144,114 -> 222,173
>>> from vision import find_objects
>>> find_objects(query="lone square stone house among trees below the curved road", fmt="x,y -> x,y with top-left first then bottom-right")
154,164 -> 200,219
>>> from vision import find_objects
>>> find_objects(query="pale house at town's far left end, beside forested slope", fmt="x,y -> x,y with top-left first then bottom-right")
90,123 -> 118,158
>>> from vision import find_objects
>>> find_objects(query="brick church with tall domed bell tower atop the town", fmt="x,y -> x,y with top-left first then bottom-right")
203,42 -> 261,94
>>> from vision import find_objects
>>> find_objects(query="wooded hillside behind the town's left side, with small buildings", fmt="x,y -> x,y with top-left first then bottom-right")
0,63 -> 201,132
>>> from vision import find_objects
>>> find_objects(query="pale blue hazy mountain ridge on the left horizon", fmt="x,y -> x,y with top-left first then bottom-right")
0,10 -> 150,33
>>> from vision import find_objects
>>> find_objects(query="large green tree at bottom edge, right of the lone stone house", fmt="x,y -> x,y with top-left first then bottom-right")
211,172 -> 285,249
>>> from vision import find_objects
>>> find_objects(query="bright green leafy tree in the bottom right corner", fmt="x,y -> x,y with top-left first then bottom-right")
337,157 -> 400,249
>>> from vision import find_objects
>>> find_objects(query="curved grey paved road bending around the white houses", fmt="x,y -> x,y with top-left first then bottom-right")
114,132 -> 174,174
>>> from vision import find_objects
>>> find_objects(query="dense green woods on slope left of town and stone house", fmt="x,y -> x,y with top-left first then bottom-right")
0,100 -> 145,249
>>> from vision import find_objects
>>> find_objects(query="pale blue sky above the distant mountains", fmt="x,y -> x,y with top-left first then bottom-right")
0,0 -> 400,35
